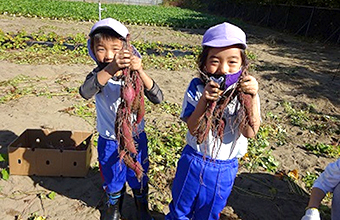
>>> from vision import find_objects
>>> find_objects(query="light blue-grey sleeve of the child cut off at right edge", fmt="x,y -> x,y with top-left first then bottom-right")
313,158 -> 340,193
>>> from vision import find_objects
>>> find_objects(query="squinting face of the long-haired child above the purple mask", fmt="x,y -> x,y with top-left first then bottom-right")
205,47 -> 242,75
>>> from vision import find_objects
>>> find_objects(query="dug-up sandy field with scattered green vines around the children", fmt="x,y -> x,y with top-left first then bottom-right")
0,0 -> 340,220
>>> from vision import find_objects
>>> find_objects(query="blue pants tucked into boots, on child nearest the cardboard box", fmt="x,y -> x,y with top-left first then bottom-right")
97,132 -> 149,193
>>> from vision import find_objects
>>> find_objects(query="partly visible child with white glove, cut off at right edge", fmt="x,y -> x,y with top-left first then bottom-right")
301,158 -> 340,220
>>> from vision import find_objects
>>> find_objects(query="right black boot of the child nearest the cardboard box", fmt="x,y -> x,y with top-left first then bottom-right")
132,187 -> 153,220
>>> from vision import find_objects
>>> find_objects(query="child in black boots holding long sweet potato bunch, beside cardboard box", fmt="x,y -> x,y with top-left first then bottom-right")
79,18 -> 163,220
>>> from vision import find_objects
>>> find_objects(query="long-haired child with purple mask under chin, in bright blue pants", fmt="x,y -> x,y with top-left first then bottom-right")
166,23 -> 260,220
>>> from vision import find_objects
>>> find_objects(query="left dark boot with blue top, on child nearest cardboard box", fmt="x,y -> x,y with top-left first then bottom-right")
104,185 -> 126,220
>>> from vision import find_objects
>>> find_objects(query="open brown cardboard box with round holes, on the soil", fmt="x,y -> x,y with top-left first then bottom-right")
8,129 -> 93,177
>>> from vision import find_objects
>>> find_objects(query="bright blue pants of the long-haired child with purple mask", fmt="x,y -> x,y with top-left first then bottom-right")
166,145 -> 238,220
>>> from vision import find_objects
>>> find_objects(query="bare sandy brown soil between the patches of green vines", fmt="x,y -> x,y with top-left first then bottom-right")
0,16 -> 340,220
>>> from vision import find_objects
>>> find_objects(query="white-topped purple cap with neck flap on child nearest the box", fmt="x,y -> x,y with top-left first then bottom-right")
87,18 -> 142,62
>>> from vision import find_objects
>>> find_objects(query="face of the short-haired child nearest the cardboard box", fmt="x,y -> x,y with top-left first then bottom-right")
93,38 -> 123,63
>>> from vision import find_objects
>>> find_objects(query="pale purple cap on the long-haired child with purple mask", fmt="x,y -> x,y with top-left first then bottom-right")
202,22 -> 247,49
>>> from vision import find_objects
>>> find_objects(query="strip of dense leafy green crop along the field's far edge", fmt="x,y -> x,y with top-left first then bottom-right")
0,0 -> 225,28
